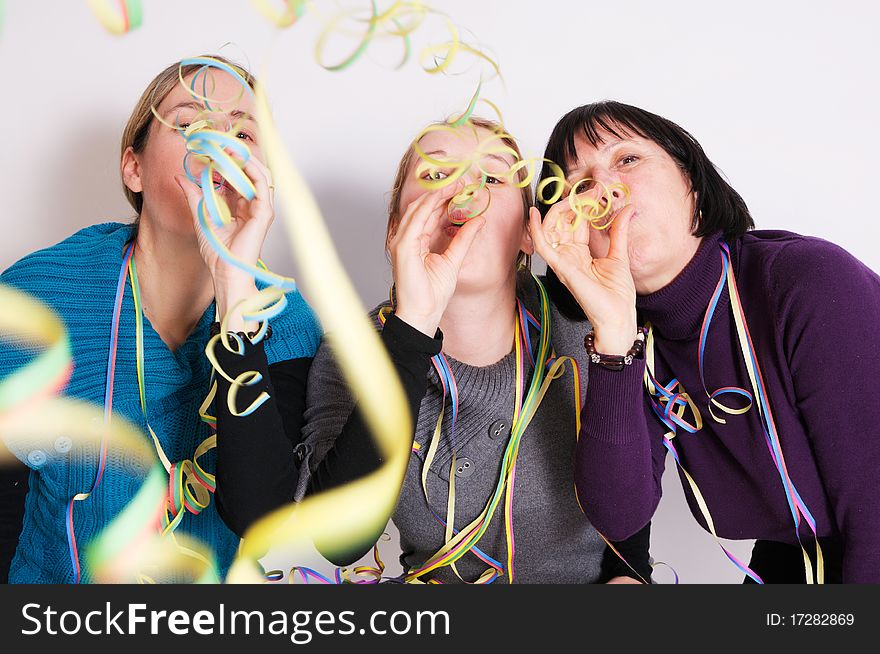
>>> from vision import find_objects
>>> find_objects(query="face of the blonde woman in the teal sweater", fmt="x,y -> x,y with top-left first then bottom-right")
123,69 -> 263,235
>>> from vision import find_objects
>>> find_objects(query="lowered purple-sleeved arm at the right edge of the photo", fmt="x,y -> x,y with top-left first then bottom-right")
768,239 -> 880,583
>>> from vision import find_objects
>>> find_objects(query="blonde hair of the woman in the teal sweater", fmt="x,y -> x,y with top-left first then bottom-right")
119,55 -> 257,217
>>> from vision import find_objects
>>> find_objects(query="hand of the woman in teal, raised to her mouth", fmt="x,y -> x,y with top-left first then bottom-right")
176,157 -> 275,331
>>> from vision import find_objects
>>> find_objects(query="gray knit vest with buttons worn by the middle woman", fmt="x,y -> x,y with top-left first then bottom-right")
298,274 -> 605,583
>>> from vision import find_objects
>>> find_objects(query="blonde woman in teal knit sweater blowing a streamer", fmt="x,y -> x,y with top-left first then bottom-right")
0,57 -> 320,583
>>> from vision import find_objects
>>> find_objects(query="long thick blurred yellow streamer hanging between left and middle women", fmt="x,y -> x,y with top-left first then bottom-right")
227,79 -> 412,582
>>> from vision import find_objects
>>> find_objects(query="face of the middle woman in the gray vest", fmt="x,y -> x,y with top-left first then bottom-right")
400,126 -> 533,290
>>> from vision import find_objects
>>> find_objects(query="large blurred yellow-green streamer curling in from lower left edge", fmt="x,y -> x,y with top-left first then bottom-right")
0,286 -> 217,581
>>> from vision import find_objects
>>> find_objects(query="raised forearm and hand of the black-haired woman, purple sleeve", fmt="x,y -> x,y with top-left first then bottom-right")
529,206 -> 665,540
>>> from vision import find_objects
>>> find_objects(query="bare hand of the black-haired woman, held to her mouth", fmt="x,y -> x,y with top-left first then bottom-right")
529,198 -> 636,355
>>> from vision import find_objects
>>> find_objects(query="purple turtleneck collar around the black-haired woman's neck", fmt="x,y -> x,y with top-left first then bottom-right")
636,232 -> 729,341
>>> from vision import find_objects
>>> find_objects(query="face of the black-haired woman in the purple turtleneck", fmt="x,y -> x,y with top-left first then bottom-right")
566,130 -> 700,295
